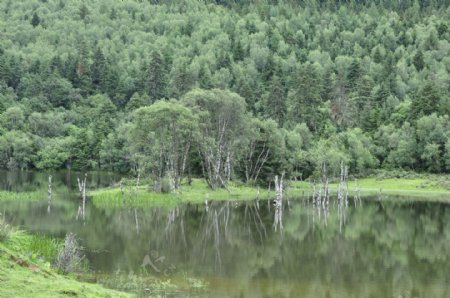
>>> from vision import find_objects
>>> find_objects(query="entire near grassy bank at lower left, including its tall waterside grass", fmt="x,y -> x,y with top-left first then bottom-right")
0,227 -> 130,297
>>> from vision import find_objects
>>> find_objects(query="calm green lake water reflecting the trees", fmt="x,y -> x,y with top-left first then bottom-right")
0,172 -> 450,297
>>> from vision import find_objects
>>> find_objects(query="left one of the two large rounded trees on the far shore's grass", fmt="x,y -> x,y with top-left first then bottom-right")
128,101 -> 198,188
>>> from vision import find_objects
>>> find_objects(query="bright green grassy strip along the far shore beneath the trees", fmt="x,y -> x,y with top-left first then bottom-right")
90,176 -> 450,207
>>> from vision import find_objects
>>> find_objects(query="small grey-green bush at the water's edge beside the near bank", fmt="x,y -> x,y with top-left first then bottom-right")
55,233 -> 84,273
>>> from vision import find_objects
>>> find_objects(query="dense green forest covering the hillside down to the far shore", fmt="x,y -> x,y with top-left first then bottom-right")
0,0 -> 450,188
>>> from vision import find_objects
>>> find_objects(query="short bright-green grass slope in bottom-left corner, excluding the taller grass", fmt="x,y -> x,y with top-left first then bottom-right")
0,232 -> 132,298
